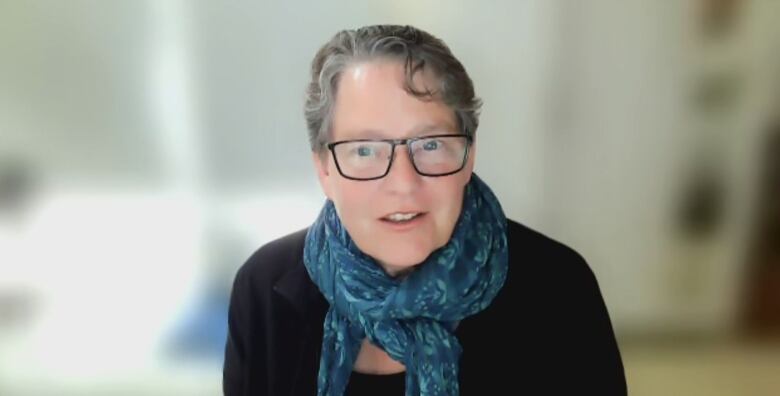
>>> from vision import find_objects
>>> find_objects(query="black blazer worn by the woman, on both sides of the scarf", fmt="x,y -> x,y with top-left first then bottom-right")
223,220 -> 626,396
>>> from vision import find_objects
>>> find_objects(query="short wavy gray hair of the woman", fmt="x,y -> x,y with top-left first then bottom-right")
304,25 -> 482,152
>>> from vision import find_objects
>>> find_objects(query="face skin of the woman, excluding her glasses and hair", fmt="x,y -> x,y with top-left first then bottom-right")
313,60 -> 475,275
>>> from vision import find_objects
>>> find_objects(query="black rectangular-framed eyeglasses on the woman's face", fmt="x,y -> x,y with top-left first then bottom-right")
326,134 -> 473,180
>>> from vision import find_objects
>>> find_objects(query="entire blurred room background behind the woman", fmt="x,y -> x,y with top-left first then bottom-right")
0,0 -> 780,396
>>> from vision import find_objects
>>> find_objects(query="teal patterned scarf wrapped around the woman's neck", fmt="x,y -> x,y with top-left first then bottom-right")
303,174 -> 508,396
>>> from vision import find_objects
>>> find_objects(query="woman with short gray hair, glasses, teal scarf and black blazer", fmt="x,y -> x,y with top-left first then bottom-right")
223,26 -> 626,396
